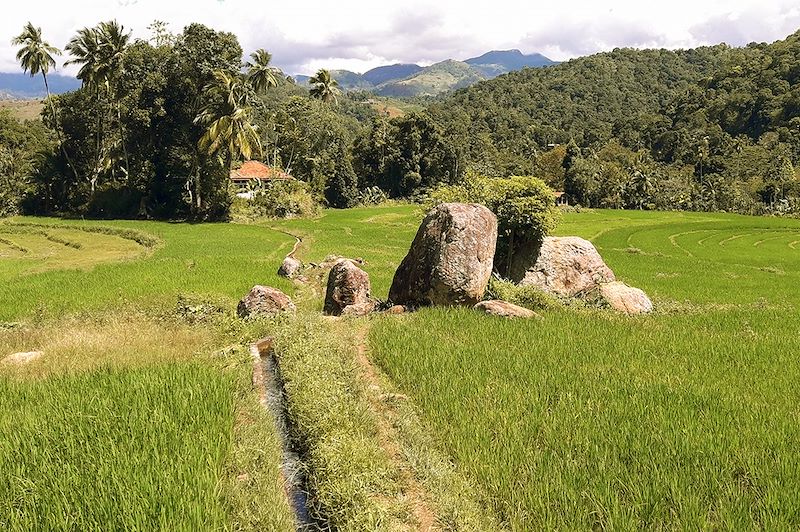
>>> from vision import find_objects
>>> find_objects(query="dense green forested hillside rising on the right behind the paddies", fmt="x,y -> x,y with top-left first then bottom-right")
430,32 -> 800,212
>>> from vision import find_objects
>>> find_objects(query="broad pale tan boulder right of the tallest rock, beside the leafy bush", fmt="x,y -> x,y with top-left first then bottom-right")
519,236 -> 616,297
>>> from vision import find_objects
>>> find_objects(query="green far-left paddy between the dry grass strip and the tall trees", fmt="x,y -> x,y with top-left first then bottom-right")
0,218 -> 294,321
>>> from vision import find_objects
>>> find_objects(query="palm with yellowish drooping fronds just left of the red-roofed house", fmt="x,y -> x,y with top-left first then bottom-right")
194,70 -> 261,207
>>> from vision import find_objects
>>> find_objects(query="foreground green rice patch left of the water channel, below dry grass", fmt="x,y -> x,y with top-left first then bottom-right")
0,364 -> 234,530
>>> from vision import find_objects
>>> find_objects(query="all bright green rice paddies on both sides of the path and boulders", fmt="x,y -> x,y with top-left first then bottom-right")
0,205 -> 800,530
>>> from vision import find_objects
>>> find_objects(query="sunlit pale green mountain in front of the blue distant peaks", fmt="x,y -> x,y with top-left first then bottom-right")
374,59 -> 487,97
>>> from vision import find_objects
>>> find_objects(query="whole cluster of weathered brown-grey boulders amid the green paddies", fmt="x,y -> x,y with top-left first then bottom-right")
238,203 -> 653,318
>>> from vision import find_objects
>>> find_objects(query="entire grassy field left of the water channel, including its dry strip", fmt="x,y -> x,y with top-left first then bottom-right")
0,219 -> 294,530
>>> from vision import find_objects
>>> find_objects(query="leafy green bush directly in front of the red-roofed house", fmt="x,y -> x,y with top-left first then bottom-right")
235,179 -> 318,218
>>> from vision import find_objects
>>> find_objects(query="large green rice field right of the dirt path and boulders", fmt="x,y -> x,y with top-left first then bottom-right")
360,206 -> 800,530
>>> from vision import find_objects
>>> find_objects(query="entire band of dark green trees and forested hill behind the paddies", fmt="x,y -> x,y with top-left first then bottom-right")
0,22 -> 800,219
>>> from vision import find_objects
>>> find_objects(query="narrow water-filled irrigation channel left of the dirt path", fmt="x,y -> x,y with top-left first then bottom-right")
250,338 -> 318,530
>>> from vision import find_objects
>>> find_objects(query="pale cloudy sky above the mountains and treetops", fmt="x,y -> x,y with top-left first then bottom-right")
0,0 -> 800,75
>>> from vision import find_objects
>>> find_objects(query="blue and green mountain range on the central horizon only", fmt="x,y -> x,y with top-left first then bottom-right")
295,50 -> 557,97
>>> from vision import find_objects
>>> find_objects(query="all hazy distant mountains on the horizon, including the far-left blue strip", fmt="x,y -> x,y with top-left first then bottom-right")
0,50 -> 556,100
